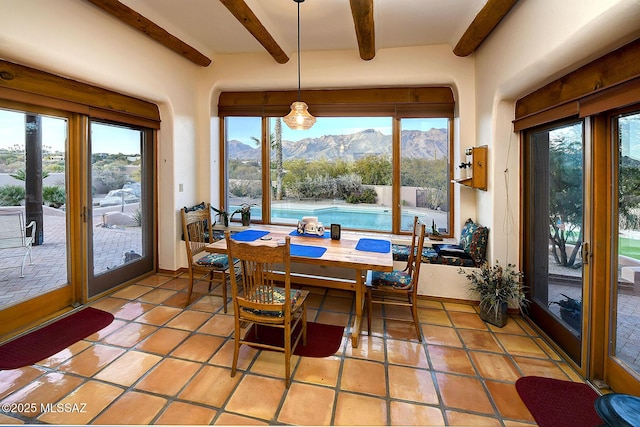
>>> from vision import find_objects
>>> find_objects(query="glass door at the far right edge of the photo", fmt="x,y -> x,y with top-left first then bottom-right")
604,110 -> 640,394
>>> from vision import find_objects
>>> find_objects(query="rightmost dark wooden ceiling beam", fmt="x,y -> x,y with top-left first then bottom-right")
453,0 -> 518,56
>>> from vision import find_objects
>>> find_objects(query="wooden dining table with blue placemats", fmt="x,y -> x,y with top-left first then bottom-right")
206,225 -> 393,348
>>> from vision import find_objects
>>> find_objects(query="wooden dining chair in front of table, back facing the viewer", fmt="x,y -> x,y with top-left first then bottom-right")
225,230 -> 309,388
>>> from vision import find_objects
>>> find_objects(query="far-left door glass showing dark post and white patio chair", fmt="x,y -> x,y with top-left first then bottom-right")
0,109 -> 68,309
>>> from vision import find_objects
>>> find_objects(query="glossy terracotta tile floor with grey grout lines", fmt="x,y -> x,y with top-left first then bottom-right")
0,275 -> 582,426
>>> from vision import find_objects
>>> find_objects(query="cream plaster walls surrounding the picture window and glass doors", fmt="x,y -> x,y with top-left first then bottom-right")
0,0 -> 640,280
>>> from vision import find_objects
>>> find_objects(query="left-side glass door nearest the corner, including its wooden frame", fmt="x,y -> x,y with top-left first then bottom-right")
85,120 -> 154,297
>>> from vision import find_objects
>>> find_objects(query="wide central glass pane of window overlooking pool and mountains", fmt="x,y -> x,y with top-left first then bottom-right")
269,117 -> 392,231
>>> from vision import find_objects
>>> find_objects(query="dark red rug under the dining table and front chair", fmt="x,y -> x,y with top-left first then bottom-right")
245,322 -> 344,357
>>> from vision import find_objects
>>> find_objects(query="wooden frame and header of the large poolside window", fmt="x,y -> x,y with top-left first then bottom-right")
218,86 -> 455,237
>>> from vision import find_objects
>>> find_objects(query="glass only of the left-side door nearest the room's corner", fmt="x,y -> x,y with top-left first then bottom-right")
91,122 -> 142,276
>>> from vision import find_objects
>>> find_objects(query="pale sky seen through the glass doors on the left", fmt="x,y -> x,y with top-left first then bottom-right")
0,109 -> 140,155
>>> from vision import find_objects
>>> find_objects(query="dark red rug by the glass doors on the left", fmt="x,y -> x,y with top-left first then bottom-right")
0,307 -> 113,370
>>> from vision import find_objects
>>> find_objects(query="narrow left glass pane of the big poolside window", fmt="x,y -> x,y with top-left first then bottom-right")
226,117 -> 264,222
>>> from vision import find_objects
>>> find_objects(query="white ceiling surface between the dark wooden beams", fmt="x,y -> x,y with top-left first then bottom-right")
120,0 -> 487,57
